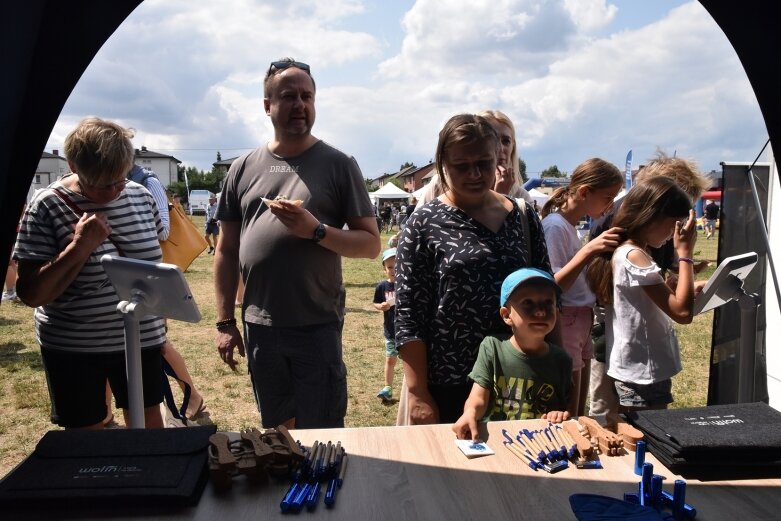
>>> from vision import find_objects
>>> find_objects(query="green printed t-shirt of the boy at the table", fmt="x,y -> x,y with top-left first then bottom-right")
469,336 -> 572,421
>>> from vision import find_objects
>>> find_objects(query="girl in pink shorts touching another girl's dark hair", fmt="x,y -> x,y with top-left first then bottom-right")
541,158 -> 624,416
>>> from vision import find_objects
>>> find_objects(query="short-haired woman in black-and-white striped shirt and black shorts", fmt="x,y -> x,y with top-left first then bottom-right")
13,118 -> 165,429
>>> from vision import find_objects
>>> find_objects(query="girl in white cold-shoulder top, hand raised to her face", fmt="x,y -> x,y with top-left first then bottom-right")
588,177 -> 697,412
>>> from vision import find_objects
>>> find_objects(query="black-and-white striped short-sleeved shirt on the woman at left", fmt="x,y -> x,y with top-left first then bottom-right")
13,176 -> 165,352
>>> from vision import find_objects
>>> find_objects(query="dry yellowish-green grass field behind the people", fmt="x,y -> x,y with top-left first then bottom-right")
0,216 -> 718,476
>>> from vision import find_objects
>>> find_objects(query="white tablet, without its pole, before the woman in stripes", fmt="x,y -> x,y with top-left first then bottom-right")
100,255 -> 201,322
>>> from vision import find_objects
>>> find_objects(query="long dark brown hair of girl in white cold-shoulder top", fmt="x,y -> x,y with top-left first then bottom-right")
586,177 -> 692,305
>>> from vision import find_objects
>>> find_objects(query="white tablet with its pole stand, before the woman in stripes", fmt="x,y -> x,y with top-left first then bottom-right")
100,255 -> 201,429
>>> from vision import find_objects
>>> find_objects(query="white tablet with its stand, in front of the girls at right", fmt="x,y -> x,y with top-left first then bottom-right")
694,252 -> 760,403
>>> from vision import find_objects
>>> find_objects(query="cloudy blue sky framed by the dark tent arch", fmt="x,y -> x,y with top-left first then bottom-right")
46,0 -> 767,179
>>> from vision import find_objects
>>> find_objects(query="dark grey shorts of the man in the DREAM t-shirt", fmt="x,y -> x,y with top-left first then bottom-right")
245,322 -> 347,429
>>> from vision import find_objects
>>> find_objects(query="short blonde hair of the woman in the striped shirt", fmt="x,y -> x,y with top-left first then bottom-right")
64,117 -> 135,186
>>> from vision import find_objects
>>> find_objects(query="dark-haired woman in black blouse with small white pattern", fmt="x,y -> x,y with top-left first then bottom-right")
395,114 -> 550,424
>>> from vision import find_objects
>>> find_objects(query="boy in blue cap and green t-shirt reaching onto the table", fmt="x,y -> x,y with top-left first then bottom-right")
453,268 -> 572,440
